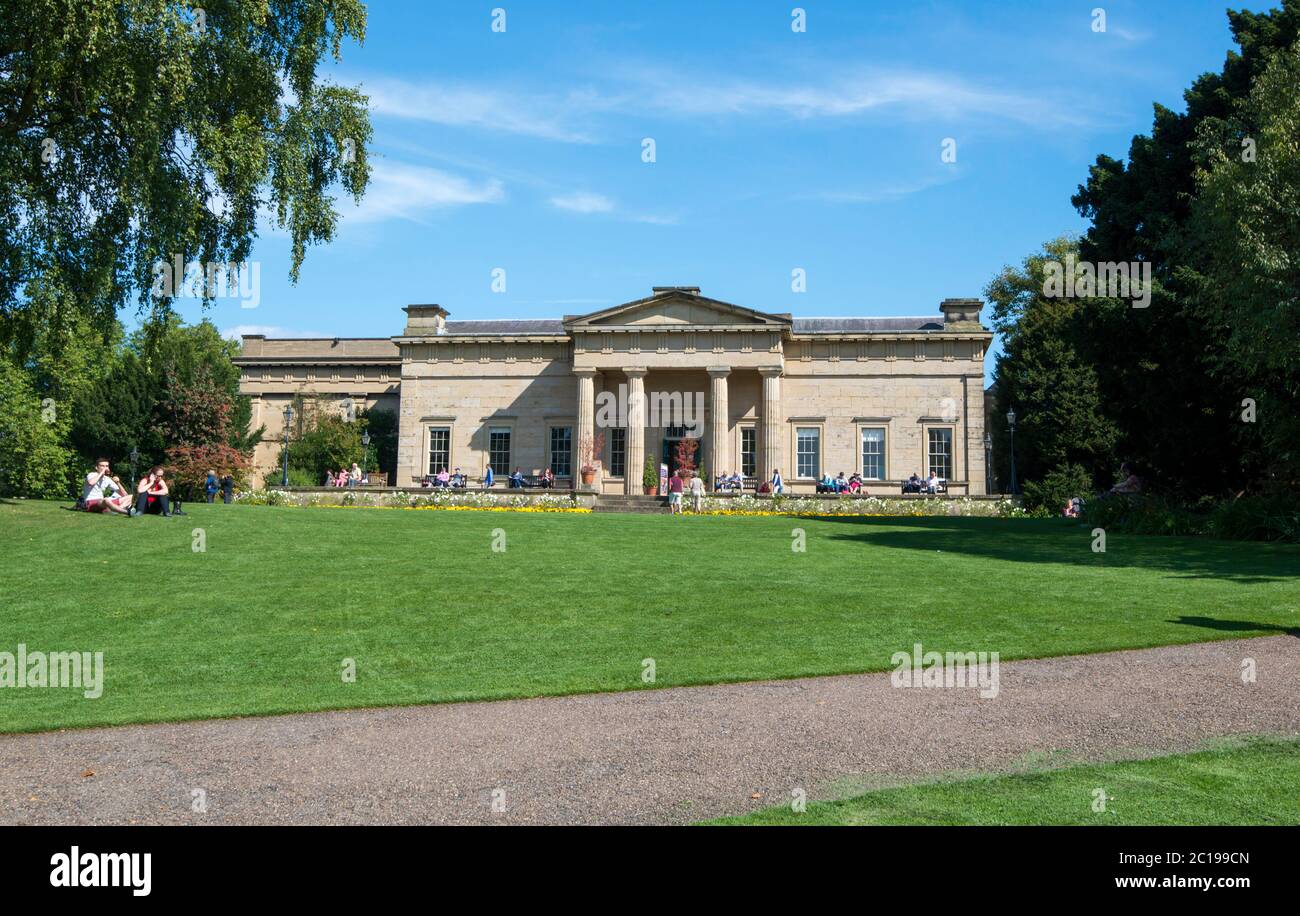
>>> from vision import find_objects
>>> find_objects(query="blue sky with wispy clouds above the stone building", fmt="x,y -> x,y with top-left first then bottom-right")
178,0 -> 1269,379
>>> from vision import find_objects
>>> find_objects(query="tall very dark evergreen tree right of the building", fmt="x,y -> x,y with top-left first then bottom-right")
1073,0 -> 1300,494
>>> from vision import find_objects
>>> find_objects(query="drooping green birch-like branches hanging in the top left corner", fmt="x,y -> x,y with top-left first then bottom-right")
0,0 -> 372,334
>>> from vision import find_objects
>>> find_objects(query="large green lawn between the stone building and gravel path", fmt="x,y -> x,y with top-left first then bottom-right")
0,502 -> 1300,732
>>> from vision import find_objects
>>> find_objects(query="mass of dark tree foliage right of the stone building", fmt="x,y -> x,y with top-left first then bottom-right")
1003,0 -> 1300,495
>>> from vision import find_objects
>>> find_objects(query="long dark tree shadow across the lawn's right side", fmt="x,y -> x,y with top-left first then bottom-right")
820,516 -> 1300,585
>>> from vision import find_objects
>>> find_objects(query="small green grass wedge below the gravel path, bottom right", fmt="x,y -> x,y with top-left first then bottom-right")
712,738 -> 1300,826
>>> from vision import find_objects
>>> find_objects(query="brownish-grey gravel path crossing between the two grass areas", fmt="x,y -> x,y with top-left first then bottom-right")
0,637 -> 1300,824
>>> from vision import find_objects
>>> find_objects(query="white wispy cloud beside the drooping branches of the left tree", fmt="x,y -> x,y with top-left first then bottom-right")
338,159 -> 506,225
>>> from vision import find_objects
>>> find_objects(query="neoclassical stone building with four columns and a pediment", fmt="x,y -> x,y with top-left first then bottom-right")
238,286 -> 992,494
